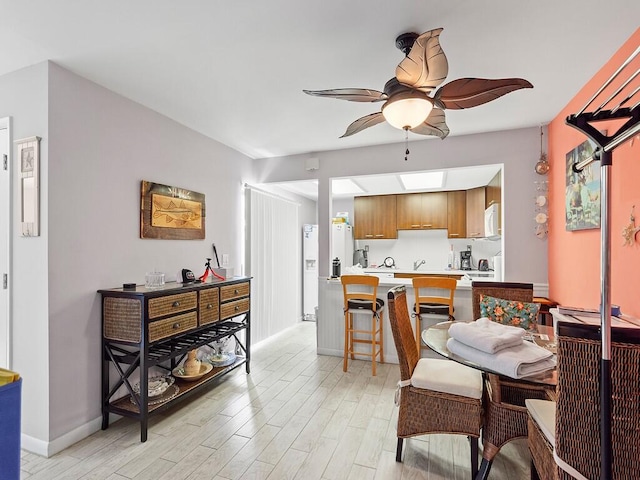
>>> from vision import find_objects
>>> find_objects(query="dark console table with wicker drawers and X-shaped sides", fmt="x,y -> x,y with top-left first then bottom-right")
98,277 -> 251,442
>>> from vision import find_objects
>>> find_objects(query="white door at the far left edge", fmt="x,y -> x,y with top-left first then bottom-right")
0,118 -> 11,368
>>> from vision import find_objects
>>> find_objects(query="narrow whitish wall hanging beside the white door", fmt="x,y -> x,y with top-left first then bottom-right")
14,137 -> 40,237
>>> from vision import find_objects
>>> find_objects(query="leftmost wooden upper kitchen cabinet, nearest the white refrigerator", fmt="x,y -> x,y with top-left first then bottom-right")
353,195 -> 398,240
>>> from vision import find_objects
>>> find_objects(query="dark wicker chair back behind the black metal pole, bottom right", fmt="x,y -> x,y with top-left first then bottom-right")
555,321 -> 640,480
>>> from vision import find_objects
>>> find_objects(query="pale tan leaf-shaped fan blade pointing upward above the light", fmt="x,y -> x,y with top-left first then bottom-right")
396,28 -> 449,93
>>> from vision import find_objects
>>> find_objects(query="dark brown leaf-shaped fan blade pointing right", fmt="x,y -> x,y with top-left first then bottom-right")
434,78 -> 533,110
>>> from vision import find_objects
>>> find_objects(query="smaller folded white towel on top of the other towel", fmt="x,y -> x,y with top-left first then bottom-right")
449,318 -> 525,353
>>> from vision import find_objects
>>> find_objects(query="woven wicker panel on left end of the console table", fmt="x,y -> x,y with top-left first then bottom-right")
102,297 -> 142,343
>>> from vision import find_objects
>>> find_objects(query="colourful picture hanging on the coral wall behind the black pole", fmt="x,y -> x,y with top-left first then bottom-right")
565,140 -> 600,231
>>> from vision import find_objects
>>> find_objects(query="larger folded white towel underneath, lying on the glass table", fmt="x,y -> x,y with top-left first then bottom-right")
447,338 -> 556,378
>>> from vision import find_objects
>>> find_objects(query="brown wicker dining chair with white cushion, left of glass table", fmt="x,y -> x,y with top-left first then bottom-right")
387,285 -> 483,478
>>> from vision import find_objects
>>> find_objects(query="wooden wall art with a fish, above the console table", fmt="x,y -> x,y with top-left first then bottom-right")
140,180 -> 206,240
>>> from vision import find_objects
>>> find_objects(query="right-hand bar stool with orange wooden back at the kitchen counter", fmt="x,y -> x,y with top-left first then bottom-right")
411,277 -> 458,352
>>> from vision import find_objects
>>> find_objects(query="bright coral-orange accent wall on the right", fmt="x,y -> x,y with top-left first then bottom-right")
548,29 -> 640,318
